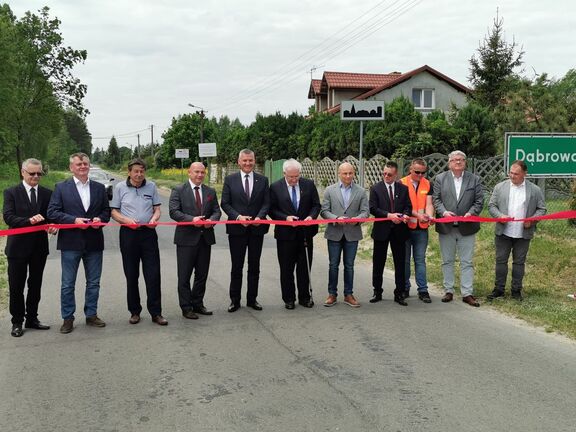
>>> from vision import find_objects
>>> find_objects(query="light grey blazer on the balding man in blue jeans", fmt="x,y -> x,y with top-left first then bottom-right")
320,183 -> 369,241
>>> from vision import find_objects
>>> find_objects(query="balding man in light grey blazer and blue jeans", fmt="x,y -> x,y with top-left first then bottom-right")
320,162 -> 369,307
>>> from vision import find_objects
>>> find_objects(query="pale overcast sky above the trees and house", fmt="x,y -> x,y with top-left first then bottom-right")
7,0 -> 576,147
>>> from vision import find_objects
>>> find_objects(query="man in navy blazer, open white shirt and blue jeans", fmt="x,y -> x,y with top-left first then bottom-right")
48,153 -> 110,334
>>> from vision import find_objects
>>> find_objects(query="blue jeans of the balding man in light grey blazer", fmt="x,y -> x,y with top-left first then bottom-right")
328,238 -> 358,296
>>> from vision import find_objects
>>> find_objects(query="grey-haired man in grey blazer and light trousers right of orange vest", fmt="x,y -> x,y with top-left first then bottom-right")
432,150 -> 484,307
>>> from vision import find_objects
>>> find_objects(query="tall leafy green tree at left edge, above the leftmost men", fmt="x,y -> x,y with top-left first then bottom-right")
0,4 -> 86,171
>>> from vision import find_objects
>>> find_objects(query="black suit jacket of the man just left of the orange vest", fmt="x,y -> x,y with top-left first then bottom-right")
369,181 -> 412,241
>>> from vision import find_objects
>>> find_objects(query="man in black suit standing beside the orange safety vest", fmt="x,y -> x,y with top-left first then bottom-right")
369,161 -> 412,306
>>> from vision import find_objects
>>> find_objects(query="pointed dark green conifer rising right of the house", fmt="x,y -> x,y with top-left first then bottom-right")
468,15 -> 524,109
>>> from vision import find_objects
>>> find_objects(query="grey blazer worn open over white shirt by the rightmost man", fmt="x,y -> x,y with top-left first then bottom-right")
488,180 -> 546,239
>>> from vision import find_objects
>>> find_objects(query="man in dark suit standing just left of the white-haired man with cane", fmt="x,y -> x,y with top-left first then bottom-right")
222,149 -> 270,312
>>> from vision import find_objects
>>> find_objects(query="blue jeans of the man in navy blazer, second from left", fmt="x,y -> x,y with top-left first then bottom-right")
60,250 -> 103,319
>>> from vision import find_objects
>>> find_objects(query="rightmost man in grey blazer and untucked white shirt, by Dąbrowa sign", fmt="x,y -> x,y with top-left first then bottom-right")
488,160 -> 546,301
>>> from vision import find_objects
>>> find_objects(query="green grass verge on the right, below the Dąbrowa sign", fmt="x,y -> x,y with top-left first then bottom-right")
359,201 -> 576,339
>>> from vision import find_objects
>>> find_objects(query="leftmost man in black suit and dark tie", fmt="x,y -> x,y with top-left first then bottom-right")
3,159 -> 56,337
